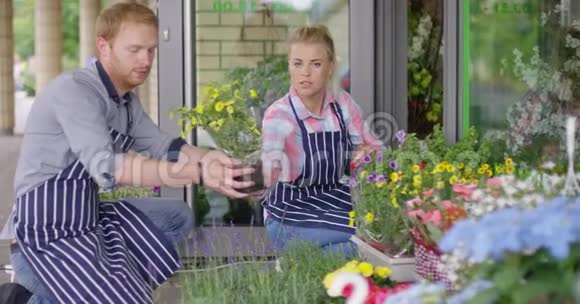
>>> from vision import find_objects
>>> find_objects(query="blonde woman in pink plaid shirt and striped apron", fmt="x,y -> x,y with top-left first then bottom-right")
262,25 -> 382,257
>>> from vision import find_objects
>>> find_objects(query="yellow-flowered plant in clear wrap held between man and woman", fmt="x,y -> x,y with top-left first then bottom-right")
177,80 -> 263,191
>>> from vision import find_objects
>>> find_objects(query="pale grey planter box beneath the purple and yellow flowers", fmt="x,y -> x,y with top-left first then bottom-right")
351,236 -> 417,282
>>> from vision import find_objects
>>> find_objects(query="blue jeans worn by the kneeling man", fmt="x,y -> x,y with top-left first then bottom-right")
10,198 -> 193,304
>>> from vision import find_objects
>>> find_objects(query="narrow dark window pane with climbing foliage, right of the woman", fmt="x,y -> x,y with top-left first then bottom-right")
407,0 -> 443,138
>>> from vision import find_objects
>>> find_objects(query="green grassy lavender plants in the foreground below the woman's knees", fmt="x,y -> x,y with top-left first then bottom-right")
182,246 -> 346,304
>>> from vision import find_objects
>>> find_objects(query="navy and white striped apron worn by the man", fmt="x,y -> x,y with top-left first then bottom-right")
14,120 -> 180,303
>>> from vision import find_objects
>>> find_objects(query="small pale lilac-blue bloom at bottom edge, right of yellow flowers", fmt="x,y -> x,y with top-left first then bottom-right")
384,283 -> 445,304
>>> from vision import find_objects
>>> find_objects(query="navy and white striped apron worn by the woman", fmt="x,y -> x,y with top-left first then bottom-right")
262,97 -> 355,233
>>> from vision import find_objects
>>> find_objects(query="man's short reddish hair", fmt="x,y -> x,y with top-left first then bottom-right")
96,3 -> 159,41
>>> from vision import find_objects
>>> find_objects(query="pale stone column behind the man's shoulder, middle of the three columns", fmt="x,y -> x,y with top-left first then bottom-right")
34,0 -> 62,95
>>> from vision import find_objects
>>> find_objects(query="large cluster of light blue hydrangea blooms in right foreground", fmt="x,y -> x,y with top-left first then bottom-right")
439,197 -> 580,262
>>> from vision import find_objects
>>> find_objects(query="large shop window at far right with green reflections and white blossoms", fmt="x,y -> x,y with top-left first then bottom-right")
463,0 -> 580,158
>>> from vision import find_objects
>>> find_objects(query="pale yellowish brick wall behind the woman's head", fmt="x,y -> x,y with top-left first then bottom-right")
196,0 -> 348,92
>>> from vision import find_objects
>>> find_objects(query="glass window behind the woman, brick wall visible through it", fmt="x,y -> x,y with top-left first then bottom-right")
193,0 -> 349,225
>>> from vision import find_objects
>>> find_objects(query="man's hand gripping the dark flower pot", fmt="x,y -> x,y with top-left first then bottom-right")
199,150 -> 254,198
